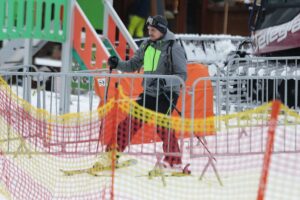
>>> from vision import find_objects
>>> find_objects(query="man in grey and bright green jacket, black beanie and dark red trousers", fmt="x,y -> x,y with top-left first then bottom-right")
107,15 -> 187,172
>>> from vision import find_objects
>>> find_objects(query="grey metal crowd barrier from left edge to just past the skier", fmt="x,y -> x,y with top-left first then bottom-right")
0,72 -> 185,159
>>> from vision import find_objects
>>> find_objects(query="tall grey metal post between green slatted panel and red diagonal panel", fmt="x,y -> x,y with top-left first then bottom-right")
59,0 -> 75,114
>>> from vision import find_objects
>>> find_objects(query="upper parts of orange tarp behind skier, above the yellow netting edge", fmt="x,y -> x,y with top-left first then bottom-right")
95,63 -> 213,118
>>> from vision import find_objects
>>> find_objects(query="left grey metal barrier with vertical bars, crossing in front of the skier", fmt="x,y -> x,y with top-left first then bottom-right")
0,71 -> 185,155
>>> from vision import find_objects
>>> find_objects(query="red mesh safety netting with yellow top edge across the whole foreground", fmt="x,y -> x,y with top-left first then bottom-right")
0,74 -> 300,200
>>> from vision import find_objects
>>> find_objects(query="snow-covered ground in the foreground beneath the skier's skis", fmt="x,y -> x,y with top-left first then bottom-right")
0,112 -> 300,200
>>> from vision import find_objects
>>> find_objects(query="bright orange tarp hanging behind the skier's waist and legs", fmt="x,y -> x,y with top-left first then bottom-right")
95,64 -> 214,144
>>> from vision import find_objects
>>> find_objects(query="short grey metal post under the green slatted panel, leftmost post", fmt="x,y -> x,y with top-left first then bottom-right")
23,39 -> 32,103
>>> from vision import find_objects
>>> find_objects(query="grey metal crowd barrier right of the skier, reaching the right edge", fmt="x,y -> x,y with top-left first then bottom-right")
190,76 -> 300,156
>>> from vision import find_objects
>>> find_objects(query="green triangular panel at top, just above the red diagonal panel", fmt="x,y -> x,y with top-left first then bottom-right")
77,0 -> 104,30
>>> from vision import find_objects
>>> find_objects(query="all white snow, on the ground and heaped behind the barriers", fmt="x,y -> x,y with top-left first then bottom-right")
0,35 -> 300,200
